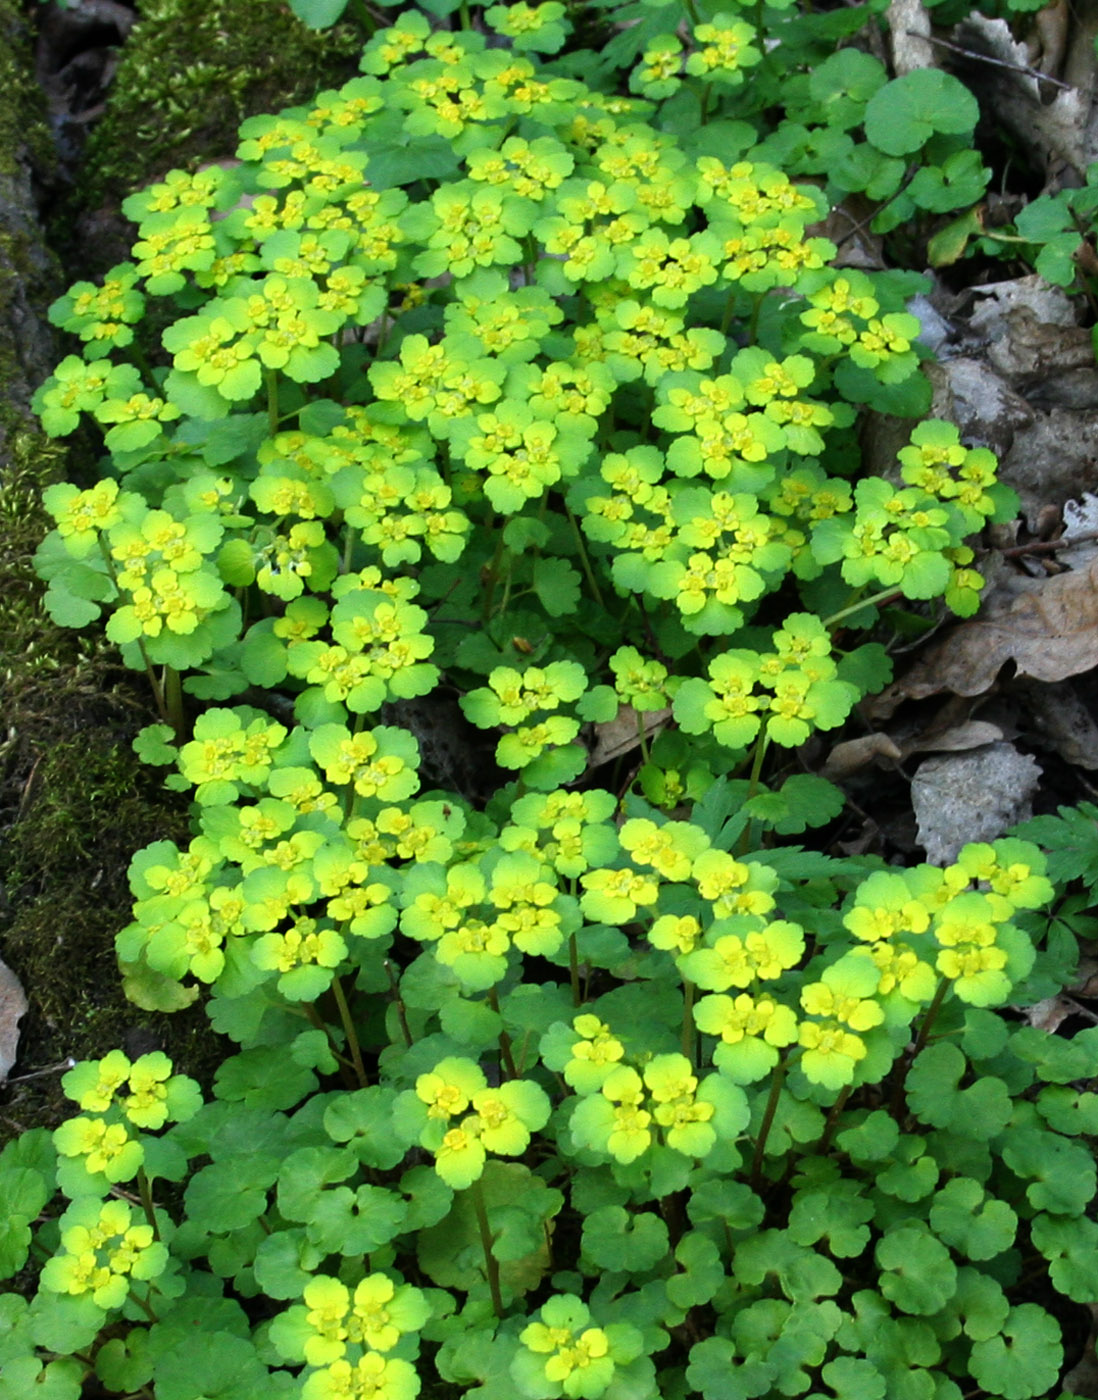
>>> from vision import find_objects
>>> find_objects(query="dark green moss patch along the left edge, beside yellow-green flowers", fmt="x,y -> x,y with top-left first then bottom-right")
0,433 -> 220,1141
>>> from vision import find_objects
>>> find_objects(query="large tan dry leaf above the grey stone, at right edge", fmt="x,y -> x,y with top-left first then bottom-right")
871,560 -> 1098,718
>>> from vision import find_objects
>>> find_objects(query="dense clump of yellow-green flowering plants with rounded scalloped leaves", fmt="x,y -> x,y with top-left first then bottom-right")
0,3 -> 1098,1400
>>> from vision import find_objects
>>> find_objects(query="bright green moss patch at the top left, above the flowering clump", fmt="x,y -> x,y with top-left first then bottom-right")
71,0 -> 363,215
